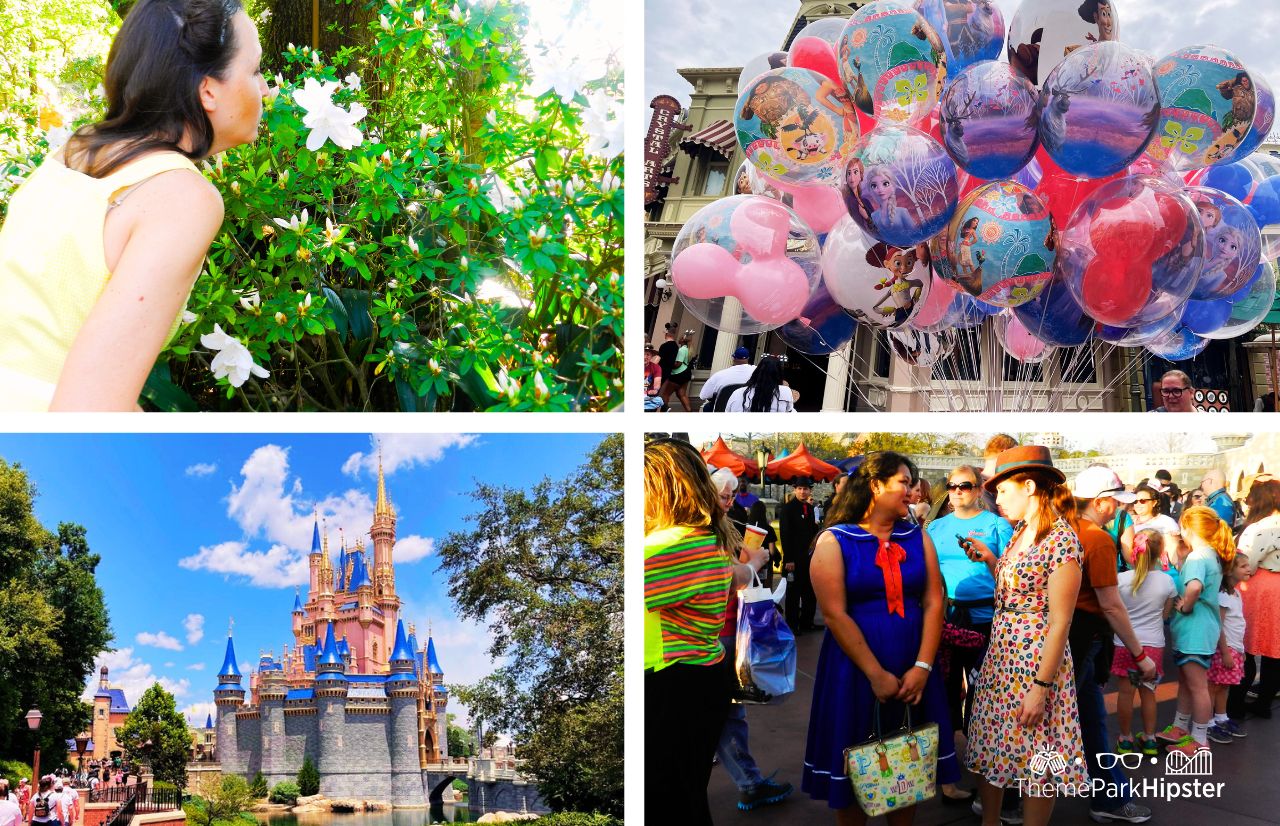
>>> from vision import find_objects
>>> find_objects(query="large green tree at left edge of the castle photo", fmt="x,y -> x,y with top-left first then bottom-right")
0,458 -> 111,768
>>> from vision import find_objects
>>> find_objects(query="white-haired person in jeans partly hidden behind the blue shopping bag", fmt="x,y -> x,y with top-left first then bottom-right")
712,467 -> 795,812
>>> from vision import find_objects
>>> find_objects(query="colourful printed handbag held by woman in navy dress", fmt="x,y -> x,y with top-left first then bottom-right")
845,702 -> 938,817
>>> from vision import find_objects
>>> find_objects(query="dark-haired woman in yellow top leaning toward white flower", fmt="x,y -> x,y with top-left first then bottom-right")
0,0 -> 266,411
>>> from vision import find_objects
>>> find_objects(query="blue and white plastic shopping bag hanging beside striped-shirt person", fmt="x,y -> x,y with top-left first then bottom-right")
735,578 -> 796,703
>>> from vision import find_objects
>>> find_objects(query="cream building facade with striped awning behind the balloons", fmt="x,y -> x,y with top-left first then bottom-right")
644,0 -> 1280,412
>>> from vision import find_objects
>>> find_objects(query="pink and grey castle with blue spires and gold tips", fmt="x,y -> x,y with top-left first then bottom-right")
214,460 -> 449,807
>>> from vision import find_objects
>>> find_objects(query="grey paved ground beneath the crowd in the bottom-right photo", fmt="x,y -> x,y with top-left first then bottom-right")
706,622 -> 1280,826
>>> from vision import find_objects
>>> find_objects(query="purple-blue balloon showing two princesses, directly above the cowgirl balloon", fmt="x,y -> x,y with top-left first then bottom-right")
842,125 -> 959,247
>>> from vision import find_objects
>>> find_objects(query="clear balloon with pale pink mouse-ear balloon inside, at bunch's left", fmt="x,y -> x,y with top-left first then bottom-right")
671,195 -> 822,336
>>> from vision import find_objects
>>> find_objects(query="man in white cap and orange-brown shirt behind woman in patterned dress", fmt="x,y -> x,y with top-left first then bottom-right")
1068,465 -> 1156,823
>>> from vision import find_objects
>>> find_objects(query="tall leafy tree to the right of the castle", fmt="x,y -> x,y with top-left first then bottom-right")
439,435 -> 623,816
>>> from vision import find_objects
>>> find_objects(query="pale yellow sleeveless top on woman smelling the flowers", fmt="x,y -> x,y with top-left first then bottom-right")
0,152 -> 197,411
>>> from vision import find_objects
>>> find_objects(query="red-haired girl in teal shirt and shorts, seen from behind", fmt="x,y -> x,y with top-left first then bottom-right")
1156,507 -> 1235,754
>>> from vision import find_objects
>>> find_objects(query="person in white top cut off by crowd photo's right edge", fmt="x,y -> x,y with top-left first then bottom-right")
1228,479 -> 1280,722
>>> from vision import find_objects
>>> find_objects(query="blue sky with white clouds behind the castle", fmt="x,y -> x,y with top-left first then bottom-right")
0,434 -> 602,724
